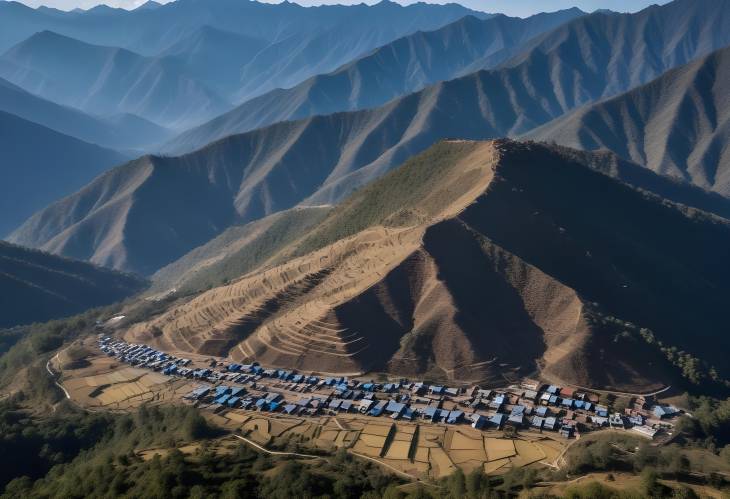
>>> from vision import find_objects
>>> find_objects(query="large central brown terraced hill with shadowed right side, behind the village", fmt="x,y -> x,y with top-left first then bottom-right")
126,140 -> 730,389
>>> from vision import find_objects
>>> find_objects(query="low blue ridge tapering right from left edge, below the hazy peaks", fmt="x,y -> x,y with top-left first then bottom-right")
0,74 -> 169,150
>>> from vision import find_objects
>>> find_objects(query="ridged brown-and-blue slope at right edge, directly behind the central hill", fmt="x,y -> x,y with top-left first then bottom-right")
528,48 -> 730,196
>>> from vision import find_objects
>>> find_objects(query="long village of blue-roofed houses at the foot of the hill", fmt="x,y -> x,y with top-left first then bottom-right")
99,337 -> 678,438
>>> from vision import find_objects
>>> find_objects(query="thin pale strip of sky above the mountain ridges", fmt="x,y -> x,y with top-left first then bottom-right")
9,0 -> 668,17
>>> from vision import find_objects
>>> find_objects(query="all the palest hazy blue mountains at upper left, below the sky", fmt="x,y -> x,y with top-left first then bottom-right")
0,0 -> 486,130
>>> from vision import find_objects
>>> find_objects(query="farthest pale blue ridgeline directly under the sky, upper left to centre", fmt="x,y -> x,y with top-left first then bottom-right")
0,0 -> 488,55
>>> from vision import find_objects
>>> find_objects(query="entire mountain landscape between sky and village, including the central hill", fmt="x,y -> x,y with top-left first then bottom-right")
0,0 -> 730,400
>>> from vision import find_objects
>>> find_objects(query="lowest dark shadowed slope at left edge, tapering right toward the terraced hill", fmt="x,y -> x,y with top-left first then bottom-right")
0,241 -> 146,327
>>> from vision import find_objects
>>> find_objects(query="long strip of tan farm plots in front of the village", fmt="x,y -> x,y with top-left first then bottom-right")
202,410 -> 566,479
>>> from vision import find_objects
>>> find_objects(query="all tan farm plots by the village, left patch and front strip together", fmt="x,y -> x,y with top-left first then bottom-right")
54,336 -> 565,479
